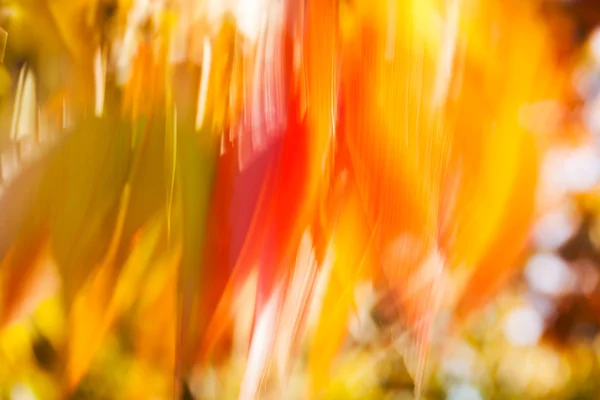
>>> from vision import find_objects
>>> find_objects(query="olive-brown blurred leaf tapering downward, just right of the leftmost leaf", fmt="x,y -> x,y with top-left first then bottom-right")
46,117 -> 130,302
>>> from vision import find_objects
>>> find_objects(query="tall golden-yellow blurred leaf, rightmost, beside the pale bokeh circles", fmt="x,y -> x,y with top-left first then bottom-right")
441,0 -> 557,267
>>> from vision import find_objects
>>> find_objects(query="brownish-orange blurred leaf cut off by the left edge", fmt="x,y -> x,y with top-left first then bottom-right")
0,134 -> 63,329
